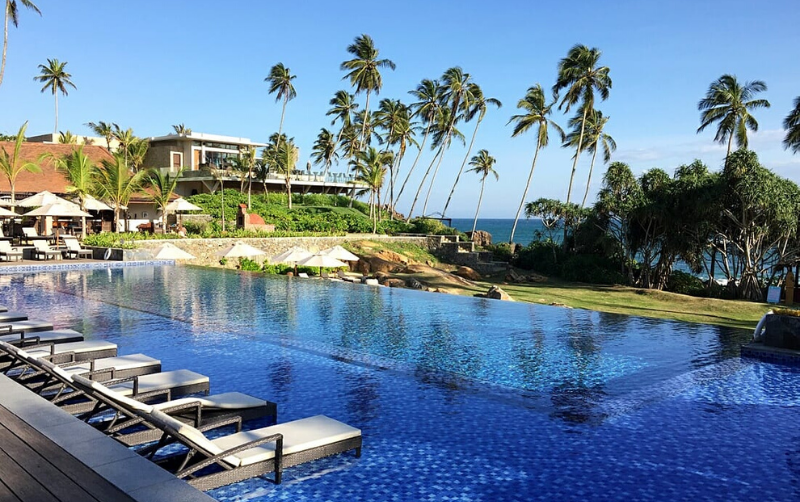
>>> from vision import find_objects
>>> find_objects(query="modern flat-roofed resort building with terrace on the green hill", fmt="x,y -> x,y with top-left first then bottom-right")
144,132 -> 361,197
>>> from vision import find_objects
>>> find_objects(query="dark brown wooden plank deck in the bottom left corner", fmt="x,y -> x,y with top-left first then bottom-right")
0,405 -> 134,502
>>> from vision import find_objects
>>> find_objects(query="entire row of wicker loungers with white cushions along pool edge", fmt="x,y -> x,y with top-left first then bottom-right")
0,306 -> 362,490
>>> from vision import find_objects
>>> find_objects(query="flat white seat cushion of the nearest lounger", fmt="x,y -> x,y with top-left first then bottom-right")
212,415 -> 361,465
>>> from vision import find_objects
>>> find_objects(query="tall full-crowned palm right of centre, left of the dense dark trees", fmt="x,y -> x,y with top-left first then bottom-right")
553,44 -> 611,206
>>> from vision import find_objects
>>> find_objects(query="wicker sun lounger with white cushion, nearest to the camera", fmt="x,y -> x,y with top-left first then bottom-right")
140,410 -> 362,490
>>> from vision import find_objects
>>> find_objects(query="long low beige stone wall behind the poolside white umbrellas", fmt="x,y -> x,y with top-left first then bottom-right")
122,234 -> 439,265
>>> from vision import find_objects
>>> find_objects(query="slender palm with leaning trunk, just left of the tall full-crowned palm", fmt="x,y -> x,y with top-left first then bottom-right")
508,84 -> 564,244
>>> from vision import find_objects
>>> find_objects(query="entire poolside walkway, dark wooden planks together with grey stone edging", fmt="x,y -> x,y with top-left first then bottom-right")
0,375 -> 214,502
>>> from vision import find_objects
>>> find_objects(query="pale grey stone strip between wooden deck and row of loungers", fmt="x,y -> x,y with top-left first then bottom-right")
0,375 -> 215,502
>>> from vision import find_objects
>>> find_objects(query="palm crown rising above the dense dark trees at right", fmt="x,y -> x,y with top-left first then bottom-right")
697,75 -> 769,162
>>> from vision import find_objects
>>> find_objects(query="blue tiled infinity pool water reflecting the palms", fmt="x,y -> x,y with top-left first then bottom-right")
0,267 -> 800,502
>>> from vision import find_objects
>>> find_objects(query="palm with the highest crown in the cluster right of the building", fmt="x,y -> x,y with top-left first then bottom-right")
339,35 -> 395,148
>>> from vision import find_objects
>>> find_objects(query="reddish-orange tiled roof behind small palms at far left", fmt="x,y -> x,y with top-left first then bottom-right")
0,141 -> 114,196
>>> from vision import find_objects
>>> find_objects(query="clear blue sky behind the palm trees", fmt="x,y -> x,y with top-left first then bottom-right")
0,0 -> 800,218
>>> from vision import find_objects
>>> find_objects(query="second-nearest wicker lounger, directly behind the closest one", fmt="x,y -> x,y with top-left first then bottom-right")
73,376 -> 277,446
